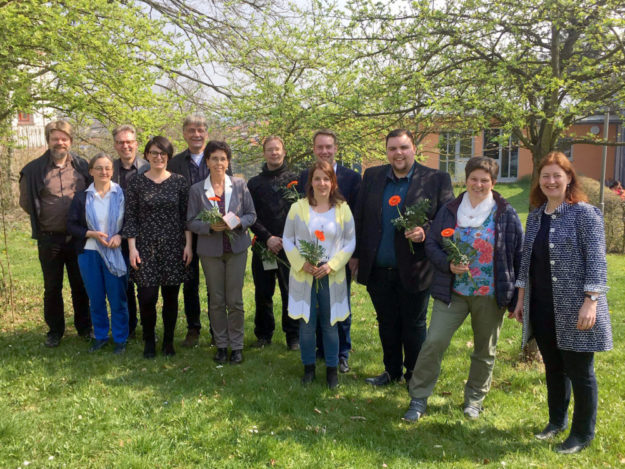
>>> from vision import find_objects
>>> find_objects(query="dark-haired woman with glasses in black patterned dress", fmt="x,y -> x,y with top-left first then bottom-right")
123,136 -> 192,358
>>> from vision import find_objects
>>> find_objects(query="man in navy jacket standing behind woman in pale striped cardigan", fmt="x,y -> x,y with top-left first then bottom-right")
298,129 -> 361,373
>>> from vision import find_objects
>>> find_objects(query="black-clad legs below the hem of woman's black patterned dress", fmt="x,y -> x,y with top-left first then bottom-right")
137,285 -> 180,344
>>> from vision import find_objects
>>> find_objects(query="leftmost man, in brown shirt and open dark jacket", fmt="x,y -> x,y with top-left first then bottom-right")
20,121 -> 92,347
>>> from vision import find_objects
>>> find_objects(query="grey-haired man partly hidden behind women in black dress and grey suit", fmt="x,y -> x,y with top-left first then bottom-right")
167,114 -> 210,347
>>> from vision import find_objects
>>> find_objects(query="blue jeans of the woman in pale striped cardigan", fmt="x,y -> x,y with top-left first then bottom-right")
299,275 -> 339,368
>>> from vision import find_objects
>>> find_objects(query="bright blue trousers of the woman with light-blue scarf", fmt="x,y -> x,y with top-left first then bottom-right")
78,249 -> 128,344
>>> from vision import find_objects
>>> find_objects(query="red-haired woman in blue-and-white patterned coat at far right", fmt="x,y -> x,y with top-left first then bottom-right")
511,152 -> 612,454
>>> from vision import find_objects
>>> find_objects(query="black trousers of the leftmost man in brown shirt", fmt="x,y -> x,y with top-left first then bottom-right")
37,233 -> 91,337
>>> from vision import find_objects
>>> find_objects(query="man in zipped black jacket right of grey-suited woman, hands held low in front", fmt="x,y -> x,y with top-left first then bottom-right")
247,135 -> 299,350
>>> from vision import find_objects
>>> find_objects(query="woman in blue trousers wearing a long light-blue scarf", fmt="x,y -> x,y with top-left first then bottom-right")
67,153 -> 128,354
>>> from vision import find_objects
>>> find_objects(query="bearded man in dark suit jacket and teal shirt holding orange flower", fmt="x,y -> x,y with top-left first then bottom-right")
350,129 -> 453,386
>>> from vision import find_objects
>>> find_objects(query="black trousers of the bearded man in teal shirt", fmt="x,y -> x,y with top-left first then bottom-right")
367,267 -> 430,381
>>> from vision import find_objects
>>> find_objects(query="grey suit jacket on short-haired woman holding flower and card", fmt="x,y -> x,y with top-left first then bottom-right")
187,176 -> 256,257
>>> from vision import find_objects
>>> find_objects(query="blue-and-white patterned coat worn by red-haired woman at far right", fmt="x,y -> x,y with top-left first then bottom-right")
516,202 -> 612,352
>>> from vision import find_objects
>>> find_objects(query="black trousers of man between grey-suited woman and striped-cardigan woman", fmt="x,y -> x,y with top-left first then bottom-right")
252,250 -> 299,344
